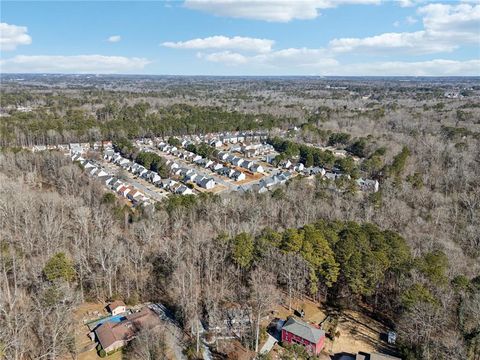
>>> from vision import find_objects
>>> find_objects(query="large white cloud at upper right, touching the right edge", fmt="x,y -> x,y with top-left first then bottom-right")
329,4 -> 480,54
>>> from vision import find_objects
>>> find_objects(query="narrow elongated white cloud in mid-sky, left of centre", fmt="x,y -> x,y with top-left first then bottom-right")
162,35 -> 275,53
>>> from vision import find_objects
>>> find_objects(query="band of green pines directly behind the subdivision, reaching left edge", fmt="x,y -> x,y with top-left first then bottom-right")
0,101 -> 291,146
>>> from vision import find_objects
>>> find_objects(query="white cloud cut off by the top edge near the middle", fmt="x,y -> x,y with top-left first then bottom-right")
184,0 -> 381,22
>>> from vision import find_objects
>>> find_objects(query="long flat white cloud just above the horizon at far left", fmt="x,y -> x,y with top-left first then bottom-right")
0,55 -> 150,74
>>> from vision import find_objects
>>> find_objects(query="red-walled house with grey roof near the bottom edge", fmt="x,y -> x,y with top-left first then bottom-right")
282,317 -> 325,355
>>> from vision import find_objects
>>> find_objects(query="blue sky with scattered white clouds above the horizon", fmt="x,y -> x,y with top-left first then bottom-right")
0,0 -> 480,76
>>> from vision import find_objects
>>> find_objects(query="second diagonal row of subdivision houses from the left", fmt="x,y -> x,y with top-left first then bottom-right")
104,149 -> 193,195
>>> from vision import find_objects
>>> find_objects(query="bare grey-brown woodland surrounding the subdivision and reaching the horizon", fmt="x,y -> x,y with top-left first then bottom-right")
0,78 -> 480,360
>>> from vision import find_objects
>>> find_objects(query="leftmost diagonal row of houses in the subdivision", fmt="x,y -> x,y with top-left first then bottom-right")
71,153 -> 152,206
